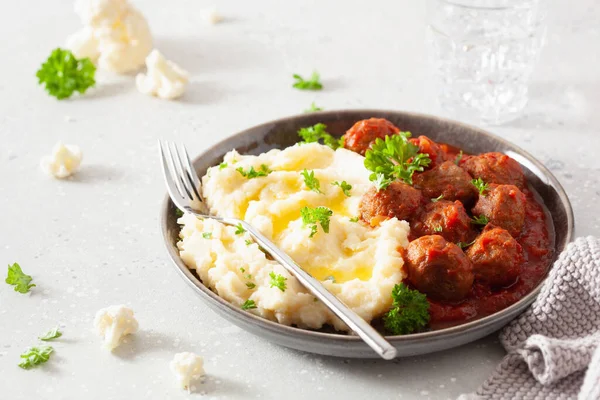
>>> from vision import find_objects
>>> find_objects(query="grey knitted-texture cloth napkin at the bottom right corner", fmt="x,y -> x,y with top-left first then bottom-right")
459,237 -> 600,400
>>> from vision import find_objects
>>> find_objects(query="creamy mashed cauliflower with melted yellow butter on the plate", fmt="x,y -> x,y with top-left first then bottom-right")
178,143 -> 409,331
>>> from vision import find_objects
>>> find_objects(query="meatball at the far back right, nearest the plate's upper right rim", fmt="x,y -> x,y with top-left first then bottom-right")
460,153 -> 525,189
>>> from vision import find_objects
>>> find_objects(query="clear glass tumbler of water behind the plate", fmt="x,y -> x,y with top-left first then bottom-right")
427,0 -> 547,125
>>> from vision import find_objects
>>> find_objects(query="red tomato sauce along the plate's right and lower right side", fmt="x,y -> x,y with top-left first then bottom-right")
429,190 -> 553,329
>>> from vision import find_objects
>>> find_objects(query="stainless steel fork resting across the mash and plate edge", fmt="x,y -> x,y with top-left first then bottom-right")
158,141 -> 396,360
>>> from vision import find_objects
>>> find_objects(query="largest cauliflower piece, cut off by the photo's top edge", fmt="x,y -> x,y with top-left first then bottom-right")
67,0 -> 152,74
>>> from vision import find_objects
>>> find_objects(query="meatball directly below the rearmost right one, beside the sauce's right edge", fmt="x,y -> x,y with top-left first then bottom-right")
471,184 -> 527,237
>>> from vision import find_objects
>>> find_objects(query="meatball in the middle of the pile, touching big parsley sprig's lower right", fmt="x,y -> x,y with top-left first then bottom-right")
413,161 -> 477,204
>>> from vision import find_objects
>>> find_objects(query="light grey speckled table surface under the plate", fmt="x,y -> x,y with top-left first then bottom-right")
0,0 -> 600,399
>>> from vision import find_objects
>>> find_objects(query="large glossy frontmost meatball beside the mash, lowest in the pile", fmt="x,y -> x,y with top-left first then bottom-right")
404,235 -> 473,301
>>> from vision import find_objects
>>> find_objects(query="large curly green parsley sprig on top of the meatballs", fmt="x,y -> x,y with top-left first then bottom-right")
365,132 -> 431,190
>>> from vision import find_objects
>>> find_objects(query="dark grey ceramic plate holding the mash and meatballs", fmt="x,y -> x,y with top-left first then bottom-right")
160,110 -> 573,358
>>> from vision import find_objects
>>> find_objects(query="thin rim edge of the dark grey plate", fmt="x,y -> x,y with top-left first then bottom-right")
159,108 -> 575,344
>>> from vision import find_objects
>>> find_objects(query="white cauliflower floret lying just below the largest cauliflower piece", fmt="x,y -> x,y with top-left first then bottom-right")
135,50 -> 189,99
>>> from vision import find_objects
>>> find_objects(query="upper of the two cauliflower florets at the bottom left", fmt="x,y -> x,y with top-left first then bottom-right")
94,305 -> 139,350
